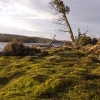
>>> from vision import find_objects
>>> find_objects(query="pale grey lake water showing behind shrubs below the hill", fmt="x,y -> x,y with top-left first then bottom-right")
0,42 -> 63,51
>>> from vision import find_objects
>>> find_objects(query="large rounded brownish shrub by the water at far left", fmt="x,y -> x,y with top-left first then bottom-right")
3,40 -> 41,56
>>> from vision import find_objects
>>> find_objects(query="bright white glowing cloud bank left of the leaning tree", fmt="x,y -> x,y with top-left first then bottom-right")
0,0 -> 53,35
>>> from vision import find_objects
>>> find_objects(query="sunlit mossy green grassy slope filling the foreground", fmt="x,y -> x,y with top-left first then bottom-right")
0,52 -> 100,100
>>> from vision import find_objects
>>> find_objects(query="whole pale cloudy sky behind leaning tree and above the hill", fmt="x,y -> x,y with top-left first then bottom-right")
0,0 -> 100,40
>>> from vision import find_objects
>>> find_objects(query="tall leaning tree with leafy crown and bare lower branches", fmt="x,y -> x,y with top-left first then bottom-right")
49,0 -> 88,45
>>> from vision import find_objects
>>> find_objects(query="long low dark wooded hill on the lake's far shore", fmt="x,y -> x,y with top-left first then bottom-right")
0,33 -> 63,43
